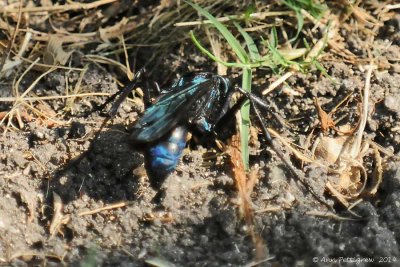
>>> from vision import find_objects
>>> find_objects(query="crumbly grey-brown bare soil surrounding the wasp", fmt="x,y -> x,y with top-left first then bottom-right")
0,1 -> 400,267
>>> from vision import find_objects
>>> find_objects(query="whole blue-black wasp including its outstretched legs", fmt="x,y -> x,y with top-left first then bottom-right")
90,69 -> 330,208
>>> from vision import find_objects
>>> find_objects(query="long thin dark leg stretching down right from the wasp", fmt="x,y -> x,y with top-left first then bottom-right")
235,86 -> 332,209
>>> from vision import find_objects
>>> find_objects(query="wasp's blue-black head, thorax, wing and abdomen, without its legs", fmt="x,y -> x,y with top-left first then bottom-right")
129,72 -> 233,186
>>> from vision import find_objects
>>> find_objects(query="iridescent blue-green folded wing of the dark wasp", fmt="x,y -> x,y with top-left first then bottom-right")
130,79 -> 213,143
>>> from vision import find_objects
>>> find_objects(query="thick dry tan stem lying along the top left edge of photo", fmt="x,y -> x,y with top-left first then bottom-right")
0,0 -> 117,13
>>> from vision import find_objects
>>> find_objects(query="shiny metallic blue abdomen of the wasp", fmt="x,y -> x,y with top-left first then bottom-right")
147,126 -> 188,183
